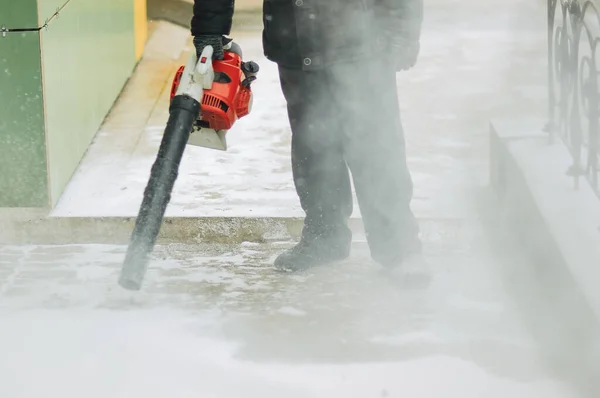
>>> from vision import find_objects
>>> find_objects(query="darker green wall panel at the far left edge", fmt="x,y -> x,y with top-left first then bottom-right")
0,0 -> 48,207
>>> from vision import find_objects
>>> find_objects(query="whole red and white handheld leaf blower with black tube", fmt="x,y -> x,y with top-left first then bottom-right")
119,42 -> 259,290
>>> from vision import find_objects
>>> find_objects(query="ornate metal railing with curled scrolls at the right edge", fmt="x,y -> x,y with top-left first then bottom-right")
548,0 -> 600,196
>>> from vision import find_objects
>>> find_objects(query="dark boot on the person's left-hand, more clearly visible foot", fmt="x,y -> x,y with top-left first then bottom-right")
274,228 -> 352,271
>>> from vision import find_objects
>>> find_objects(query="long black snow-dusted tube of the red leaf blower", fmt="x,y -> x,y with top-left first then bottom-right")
119,95 -> 200,290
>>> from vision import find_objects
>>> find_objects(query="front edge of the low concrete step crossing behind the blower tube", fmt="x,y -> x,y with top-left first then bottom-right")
0,213 -> 469,245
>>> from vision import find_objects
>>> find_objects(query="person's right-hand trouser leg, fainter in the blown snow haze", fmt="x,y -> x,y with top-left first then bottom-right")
331,61 -> 421,266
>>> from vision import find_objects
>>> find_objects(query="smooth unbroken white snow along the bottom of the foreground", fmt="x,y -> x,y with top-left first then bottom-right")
0,310 -> 576,398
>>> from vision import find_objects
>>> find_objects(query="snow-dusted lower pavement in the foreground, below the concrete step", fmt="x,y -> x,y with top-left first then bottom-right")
0,222 -> 576,398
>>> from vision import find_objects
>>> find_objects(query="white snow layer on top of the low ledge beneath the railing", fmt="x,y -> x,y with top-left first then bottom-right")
508,123 -> 600,316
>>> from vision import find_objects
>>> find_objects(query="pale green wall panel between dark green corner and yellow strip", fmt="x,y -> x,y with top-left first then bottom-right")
39,0 -> 136,205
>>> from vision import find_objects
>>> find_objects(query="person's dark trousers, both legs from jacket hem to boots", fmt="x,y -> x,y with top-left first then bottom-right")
279,60 -> 420,263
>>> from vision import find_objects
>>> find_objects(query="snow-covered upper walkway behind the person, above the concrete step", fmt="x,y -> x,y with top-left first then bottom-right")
52,1 -> 545,218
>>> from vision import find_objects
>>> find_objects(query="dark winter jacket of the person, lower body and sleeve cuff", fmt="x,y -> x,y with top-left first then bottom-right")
192,0 -> 423,70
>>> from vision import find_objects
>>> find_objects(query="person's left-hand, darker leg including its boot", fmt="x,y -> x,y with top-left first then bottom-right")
275,68 -> 352,269
